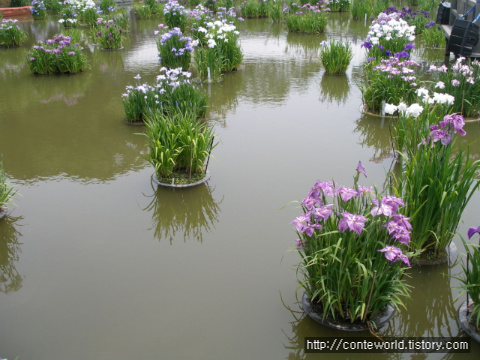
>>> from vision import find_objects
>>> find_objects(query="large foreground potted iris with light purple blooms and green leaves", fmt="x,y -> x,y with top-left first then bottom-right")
292,162 -> 411,330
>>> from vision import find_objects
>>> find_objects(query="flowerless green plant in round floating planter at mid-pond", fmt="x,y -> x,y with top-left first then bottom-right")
145,113 -> 217,187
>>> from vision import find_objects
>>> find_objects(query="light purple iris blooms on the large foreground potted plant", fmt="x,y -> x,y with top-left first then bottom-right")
291,162 -> 412,266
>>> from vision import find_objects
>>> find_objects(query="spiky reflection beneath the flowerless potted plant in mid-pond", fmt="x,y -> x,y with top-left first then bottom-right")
144,184 -> 223,245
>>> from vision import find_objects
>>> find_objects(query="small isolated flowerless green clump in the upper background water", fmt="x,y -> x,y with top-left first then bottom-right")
320,40 -> 353,74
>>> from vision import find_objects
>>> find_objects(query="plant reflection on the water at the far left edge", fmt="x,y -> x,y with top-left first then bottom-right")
0,216 -> 23,294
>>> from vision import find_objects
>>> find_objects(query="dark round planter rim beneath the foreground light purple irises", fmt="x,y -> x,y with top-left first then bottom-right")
302,293 -> 395,331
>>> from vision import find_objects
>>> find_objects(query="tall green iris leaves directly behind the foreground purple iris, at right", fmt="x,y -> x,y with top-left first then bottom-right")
392,105 -> 480,259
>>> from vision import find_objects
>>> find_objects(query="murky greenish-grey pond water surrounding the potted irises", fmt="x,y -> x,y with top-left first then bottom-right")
0,9 -> 480,360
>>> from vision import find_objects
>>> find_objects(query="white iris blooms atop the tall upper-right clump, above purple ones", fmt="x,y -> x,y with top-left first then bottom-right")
367,13 -> 415,45
